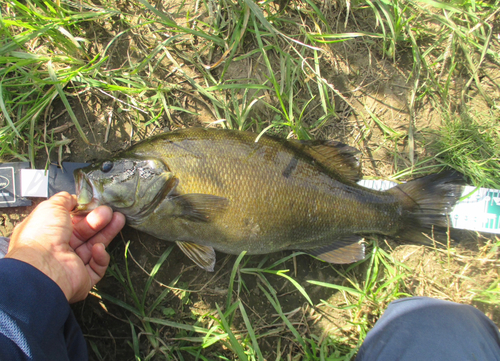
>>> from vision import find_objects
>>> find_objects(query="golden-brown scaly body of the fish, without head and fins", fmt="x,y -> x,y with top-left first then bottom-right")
128,131 -> 397,250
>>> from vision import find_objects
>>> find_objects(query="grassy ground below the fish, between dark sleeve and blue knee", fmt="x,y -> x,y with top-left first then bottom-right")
93,235 -> 499,360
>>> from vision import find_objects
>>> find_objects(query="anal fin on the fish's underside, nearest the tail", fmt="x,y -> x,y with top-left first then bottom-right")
307,236 -> 365,264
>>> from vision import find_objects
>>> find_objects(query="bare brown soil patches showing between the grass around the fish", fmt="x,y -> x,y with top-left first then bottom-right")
0,2 -> 500,360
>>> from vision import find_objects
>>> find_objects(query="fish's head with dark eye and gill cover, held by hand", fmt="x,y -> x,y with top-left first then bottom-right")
73,157 -> 175,221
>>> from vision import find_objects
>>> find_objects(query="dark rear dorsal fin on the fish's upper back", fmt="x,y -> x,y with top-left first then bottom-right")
289,140 -> 361,182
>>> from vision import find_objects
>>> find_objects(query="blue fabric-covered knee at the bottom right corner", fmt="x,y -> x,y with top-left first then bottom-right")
356,297 -> 500,361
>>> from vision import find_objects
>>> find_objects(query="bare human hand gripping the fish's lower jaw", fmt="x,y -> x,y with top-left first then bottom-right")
5,192 -> 125,303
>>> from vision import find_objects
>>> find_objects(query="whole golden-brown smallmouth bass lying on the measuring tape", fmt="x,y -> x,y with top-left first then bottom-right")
74,128 -> 463,271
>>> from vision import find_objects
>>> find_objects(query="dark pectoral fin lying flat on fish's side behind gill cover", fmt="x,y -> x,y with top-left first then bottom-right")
172,193 -> 229,222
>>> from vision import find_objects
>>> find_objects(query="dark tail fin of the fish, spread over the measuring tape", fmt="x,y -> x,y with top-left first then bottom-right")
388,172 -> 464,244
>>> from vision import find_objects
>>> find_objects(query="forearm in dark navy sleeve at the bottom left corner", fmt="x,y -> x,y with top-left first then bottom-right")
0,259 -> 88,360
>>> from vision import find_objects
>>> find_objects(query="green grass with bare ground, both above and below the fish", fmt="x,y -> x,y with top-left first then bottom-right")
0,0 -> 500,360
